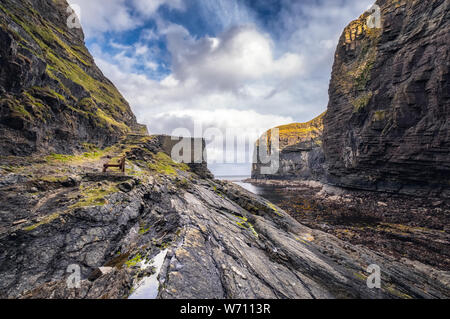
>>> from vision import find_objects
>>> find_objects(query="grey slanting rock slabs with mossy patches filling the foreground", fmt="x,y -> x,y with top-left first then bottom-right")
0,137 -> 449,298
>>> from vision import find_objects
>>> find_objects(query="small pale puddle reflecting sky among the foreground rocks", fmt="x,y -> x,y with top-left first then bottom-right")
128,249 -> 167,299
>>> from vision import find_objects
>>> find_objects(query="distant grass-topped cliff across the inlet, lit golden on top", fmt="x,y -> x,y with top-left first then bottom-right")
252,113 -> 325,180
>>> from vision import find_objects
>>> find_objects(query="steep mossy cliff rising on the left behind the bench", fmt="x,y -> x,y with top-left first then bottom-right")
0,0 -> 145,155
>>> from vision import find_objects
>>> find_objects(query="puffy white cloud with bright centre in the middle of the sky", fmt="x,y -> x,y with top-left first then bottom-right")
167,26 -> 304,95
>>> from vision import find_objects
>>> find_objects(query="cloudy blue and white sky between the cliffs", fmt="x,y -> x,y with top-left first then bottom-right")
68,0 -> 374,175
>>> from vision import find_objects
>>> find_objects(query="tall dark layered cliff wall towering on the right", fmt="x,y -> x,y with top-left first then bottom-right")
324,0 -> 450,197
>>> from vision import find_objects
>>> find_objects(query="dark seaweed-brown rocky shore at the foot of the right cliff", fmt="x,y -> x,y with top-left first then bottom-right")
249,180 -> 450,271
